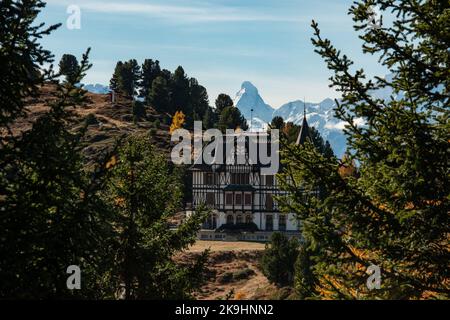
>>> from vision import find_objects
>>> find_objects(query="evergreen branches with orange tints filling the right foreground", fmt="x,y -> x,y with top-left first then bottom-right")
281,0 -> 450,299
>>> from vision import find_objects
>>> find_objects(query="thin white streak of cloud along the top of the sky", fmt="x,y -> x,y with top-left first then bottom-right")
47,0 -> 305,23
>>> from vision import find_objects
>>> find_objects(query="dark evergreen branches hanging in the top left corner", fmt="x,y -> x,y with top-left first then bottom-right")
0,0 -> 59,128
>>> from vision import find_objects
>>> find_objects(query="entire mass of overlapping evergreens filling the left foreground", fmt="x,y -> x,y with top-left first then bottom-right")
0,0 -> 210,299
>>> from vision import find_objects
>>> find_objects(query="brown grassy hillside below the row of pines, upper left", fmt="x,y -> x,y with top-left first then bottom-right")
11,85 -> 174,166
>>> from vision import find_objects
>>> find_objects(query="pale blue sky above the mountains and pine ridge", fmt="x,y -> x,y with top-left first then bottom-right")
39,0 -> 386,108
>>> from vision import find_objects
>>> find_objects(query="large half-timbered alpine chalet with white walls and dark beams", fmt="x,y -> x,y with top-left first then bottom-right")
186,116 -> 310,241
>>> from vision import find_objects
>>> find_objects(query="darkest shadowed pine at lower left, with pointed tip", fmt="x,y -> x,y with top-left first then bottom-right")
0,48 -> 116,299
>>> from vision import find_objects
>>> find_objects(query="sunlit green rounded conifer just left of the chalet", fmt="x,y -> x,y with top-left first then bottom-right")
105,137 -> 206,299
